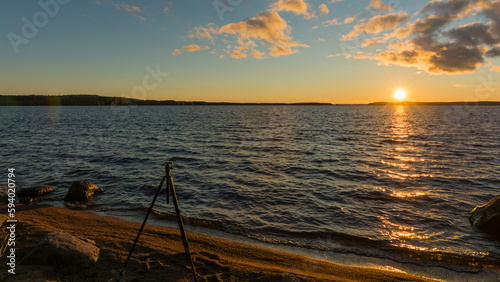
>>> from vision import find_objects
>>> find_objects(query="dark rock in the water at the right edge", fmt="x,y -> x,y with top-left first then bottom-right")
469,196 -> 500,231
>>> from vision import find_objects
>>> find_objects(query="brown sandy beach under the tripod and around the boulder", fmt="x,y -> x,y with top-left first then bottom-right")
0,205 -> 438,281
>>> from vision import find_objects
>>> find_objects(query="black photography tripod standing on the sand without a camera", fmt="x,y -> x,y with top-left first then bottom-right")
116,162 -> 198,282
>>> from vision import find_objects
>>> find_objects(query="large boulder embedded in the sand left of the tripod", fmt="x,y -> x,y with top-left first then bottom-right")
21,232 -> 100,273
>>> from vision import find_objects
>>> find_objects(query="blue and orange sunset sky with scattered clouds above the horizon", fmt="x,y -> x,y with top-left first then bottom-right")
0,0 -> 500,103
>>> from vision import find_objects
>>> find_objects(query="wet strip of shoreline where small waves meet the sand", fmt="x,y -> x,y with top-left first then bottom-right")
88,206 -> 500,281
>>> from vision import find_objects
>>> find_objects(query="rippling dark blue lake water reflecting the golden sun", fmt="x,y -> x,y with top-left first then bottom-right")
0,106 -> 500,274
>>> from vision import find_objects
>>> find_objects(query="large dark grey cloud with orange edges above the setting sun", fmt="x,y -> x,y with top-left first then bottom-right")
344,0 -> 500,74
